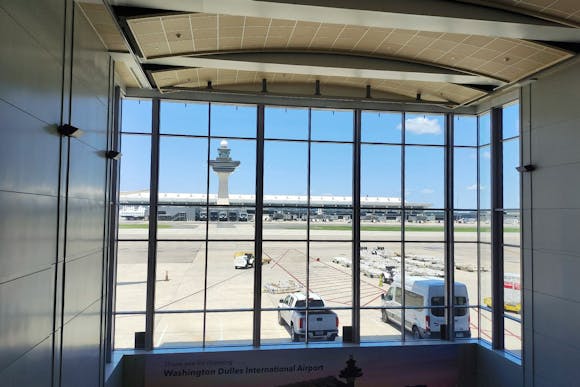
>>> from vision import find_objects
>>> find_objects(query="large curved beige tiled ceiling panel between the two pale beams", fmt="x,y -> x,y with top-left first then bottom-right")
128,14 -> 572,82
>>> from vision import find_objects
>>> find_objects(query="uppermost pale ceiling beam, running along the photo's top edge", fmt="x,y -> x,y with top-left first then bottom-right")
109,0 -> 580,42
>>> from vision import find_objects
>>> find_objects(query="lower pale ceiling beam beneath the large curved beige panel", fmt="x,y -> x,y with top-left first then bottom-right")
142,51 -> 505,87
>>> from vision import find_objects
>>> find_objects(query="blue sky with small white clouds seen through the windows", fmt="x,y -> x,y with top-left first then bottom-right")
121,99 -> 519,209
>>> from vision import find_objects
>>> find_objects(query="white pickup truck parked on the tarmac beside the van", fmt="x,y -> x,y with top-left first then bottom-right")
278,292 -> 338,341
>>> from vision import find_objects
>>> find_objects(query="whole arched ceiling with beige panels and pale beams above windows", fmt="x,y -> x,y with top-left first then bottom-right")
81,0 -> 580,107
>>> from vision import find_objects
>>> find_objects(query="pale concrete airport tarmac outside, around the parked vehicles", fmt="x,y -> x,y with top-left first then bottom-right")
115,221 -> 521,352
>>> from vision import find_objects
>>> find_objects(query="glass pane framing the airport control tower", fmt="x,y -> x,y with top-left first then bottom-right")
209,140 -> 256,200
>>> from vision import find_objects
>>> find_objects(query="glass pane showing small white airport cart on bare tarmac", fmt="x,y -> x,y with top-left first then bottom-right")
206,242 -> 255,310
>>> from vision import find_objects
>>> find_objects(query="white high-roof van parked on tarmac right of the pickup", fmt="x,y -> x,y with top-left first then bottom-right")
381,277 -> 471,339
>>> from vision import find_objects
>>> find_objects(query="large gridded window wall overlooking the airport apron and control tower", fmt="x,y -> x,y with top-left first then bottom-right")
115,99 -> 521,356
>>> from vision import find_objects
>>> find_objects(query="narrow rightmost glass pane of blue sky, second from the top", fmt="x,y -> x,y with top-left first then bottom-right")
503,139 -> 520,208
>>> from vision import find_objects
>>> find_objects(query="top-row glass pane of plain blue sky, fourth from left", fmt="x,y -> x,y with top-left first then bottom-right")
264,106 -> 308,140
